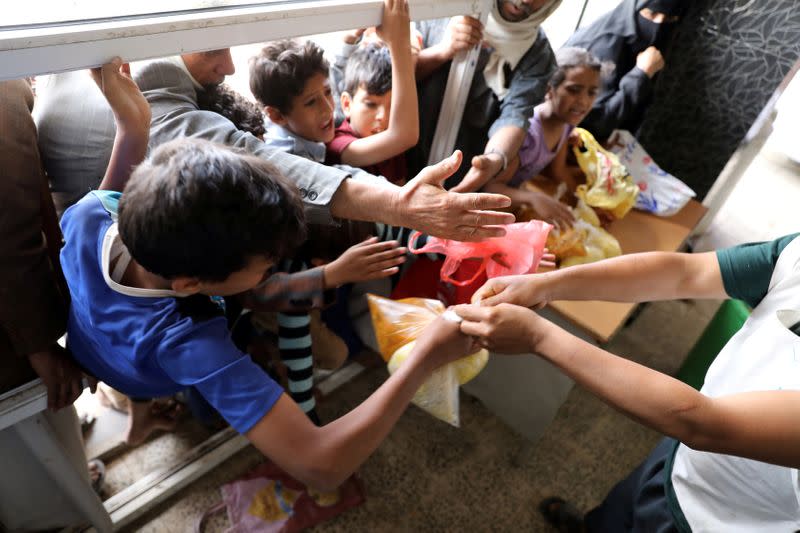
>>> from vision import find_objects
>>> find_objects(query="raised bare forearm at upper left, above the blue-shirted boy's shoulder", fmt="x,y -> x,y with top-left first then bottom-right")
91,57 -> 150,191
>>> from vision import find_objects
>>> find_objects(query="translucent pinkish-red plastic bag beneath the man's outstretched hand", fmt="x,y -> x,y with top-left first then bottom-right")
408,220 -> 553,287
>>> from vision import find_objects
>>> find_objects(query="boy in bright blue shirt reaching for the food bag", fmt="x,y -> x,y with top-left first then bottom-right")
61,59 -> 472,490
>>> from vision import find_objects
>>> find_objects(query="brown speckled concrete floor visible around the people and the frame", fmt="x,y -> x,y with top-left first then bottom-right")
112,80 -> 800,532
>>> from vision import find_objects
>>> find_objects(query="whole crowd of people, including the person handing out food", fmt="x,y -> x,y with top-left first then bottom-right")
6,0 -> 800,531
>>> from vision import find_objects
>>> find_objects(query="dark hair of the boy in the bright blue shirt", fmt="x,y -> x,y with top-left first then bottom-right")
119,139 -> 306,282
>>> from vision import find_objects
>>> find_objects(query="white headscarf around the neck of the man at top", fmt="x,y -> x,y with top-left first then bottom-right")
483,0 -> 561,100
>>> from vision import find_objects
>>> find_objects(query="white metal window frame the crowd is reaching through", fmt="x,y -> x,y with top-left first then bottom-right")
0,0 -> 494,531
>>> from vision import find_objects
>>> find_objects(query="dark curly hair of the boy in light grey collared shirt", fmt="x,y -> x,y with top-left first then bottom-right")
250,39 -> 329,114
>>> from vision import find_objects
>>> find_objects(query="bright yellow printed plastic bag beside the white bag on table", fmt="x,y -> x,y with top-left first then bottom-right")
572,128 -> 639,219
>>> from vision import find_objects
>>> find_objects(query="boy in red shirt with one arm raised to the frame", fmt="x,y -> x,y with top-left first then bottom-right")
326,0 -> 419,185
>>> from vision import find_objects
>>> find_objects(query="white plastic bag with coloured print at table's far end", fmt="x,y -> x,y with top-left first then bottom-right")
609,130 -> 696,217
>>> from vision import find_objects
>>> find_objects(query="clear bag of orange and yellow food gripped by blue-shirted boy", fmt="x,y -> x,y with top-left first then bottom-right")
367,294 -> 489,427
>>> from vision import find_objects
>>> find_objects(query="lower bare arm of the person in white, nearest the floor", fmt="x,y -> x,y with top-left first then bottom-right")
456,304 -> 800,468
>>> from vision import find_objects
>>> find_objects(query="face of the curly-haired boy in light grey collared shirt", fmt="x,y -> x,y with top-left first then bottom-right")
266,72 -> 335,143
